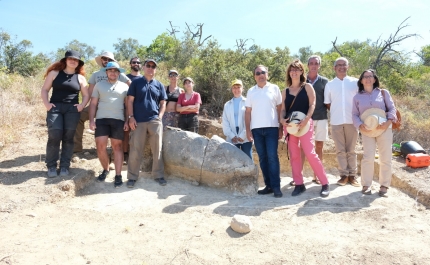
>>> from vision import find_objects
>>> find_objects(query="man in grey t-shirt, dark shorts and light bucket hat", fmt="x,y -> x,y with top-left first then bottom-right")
89,62 -> 128,187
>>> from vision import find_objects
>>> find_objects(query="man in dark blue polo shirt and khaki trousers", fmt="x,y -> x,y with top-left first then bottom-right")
127,59 -> 167,188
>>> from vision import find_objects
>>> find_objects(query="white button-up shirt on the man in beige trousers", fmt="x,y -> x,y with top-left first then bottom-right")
324,76 -> 358,125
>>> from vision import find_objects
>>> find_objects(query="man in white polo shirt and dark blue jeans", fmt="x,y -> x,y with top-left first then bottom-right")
245,65 -> 282,198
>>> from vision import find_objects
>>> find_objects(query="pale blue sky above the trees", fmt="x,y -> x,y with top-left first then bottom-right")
0,0 -> 430,60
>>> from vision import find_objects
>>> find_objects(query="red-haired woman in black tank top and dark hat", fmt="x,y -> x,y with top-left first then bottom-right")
41,50 -> 89,178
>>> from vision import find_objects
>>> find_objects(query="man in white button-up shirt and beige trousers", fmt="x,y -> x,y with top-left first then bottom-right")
324,57 -> 360,187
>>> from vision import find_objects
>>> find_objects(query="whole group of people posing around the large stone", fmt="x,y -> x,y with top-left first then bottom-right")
41,51 -> 396,198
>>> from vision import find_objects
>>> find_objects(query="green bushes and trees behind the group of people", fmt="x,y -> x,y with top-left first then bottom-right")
0,27 -> 430,150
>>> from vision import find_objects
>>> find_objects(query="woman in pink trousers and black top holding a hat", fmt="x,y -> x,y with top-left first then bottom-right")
279,59 -> 330,197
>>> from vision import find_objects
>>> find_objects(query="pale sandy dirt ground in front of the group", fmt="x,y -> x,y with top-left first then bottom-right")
0,125 -> 430,264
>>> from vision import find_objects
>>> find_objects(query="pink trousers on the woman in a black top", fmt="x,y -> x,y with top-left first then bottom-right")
288,119 -> 328,185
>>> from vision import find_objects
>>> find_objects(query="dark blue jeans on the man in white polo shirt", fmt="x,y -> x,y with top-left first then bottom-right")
252,127 -> 281,189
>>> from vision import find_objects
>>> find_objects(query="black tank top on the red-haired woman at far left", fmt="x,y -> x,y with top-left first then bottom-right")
49,71 -> 81,104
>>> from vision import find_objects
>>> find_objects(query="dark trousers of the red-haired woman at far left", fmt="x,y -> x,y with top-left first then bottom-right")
45,103 -> 81,168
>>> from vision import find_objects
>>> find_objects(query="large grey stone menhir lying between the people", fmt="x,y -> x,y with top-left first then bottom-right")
143,128 -> 258,195
